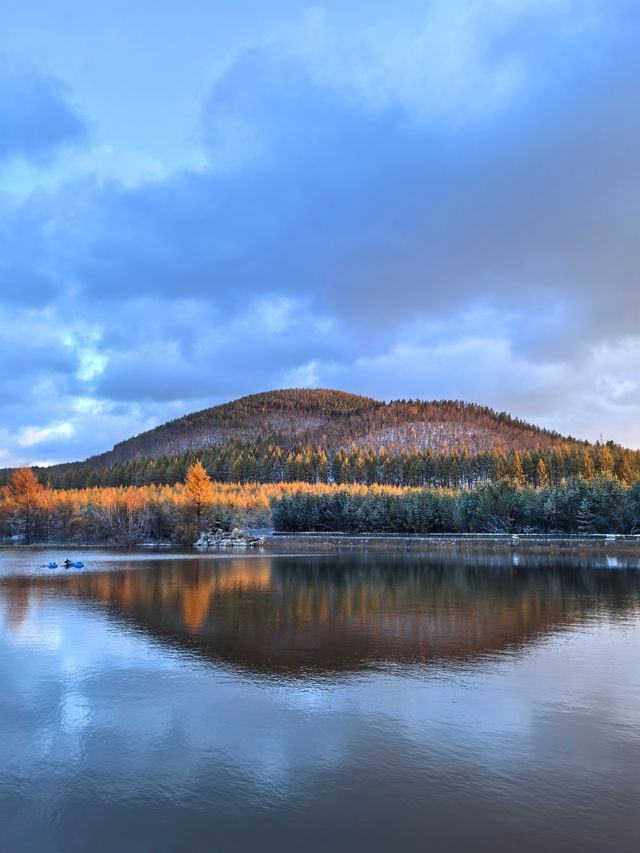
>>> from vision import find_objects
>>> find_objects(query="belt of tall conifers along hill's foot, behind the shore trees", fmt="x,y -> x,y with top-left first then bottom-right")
8,441 -> 640,489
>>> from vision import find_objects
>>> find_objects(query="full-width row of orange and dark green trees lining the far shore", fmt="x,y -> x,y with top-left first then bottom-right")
0,461 -> 640,545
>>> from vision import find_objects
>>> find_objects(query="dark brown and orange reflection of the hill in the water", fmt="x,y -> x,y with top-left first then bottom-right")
2,554 -> 640,674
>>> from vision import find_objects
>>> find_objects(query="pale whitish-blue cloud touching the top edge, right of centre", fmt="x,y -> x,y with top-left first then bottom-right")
264,0 -> 601,120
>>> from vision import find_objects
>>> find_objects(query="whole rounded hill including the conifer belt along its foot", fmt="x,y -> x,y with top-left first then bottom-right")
0,389 -> 640,489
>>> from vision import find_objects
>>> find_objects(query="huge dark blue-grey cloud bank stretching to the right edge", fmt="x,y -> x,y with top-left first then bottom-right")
66,20 -> 640,350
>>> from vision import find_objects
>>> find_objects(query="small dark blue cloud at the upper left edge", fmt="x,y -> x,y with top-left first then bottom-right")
0,62 -> 87,165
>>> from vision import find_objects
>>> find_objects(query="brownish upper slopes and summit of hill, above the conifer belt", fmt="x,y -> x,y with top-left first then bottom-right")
87,389 -> 572,466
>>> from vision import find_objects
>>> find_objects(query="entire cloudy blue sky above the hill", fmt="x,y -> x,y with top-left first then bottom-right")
0,0 -> 640,466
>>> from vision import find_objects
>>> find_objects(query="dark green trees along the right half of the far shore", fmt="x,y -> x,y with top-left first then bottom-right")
272,476 -> 640,535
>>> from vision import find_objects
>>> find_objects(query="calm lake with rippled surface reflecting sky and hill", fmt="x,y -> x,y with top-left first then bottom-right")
0,549 -> 640,853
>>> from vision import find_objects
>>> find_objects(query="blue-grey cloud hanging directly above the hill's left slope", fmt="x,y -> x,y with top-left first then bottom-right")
94,296 -> 339,407
